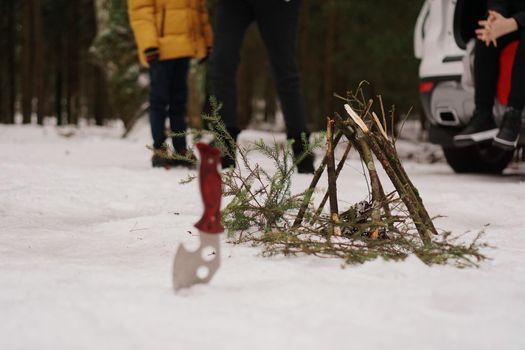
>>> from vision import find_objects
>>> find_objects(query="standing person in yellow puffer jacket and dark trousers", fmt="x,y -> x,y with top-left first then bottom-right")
128,0 -> 212,167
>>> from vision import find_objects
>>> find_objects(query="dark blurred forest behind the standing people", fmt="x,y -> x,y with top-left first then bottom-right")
0,0 -> 423,130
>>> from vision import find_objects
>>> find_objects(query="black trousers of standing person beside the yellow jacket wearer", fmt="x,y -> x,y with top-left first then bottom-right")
212,0 -> 307,138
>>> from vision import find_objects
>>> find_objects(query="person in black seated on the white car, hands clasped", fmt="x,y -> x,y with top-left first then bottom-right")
454,0 -> 525,150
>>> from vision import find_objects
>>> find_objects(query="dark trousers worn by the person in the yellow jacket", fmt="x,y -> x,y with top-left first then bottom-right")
149,58 -> 190,152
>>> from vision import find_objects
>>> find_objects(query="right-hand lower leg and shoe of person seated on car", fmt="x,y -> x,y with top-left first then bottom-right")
494,29 -> 525,150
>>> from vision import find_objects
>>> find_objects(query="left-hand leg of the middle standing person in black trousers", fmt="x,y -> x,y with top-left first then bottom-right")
211,0 -> 253,130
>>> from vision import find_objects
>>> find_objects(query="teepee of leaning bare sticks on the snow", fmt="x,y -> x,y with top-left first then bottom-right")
294,101 -> 438,247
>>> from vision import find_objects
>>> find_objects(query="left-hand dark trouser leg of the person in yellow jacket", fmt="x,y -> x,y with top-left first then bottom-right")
149,61 -> 169,150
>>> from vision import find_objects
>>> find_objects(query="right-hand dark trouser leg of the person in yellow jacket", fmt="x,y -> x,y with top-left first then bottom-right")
166,58 -> 190,153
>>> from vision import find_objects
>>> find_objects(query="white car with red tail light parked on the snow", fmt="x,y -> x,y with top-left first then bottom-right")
414,0 -> 525,173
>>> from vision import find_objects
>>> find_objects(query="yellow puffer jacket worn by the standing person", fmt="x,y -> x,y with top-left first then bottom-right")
128,0 -> 212,67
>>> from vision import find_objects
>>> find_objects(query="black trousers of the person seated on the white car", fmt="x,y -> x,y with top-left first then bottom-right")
474,23 -> 525,112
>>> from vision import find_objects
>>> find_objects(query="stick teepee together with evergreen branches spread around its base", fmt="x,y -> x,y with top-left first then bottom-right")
195,95 -> 485,267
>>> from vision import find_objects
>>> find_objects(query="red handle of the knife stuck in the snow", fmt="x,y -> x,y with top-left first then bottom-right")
195,142 -> 224,233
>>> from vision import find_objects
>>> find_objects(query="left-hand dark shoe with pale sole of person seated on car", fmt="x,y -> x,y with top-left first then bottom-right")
454,110 -> 498,147
